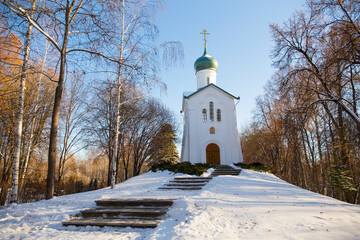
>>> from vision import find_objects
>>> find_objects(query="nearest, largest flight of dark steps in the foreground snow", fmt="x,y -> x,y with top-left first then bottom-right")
62,198 -> 174,228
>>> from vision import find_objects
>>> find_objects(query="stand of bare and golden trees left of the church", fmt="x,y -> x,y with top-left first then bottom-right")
0,0 -> 183,205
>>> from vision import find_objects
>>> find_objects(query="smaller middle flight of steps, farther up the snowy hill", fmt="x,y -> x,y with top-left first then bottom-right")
159,177 -> 212,190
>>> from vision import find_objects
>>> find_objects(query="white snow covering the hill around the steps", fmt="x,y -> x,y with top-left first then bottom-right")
0,170 -> 360,240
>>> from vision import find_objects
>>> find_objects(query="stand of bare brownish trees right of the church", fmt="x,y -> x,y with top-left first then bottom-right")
242,0 -> 360,203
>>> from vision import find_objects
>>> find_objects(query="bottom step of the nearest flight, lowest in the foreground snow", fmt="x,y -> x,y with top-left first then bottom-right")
62,218 -> 160,228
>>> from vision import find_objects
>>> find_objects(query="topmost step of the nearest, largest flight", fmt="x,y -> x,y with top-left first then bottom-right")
95,198 -> 174,207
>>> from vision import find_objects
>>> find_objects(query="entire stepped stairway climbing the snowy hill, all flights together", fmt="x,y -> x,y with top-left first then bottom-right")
62,165 -> 241,228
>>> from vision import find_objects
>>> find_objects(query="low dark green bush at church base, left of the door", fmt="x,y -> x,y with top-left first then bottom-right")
151,162 -> 216,176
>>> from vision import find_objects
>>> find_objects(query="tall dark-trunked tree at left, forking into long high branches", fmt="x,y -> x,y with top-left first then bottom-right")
1,0 -> 112,199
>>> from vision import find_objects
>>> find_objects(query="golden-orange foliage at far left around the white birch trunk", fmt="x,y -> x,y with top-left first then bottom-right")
0,28 -> 55,205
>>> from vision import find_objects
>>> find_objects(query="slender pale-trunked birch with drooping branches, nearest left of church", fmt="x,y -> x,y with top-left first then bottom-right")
95,0 -> 182,188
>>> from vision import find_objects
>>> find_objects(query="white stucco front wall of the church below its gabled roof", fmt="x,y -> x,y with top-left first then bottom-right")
181,86 -> 243,164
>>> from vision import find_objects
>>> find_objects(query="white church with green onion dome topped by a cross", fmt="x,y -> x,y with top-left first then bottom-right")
181,30 -> 243,165
